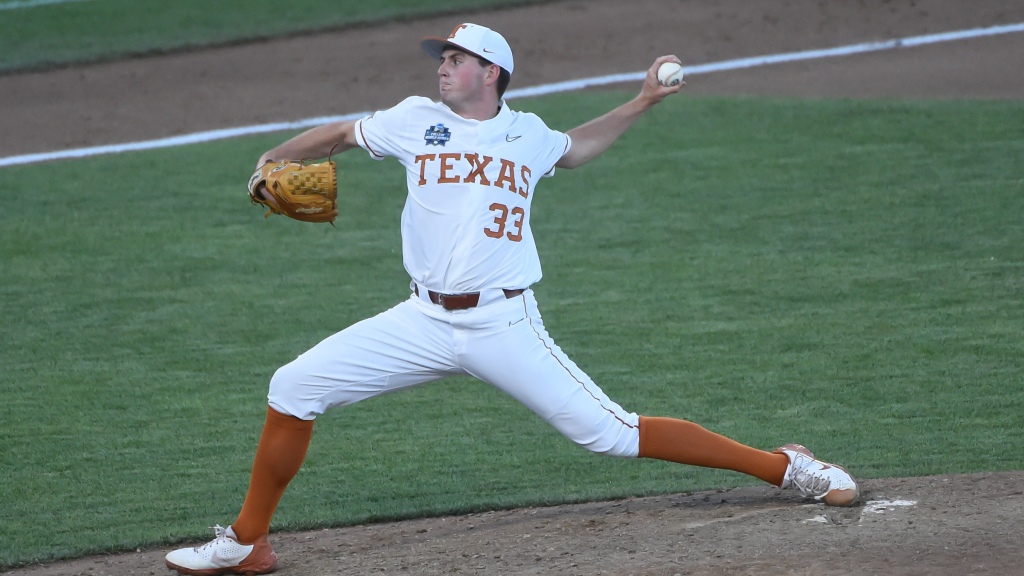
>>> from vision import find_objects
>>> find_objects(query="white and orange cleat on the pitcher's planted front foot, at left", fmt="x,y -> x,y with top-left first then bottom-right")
165,526 -> 278,576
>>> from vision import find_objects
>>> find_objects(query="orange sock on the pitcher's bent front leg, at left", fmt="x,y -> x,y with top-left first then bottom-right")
231,407 -> 313,543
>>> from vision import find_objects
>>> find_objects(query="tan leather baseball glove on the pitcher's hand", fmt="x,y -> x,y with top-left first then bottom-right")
249,160 -> 338,224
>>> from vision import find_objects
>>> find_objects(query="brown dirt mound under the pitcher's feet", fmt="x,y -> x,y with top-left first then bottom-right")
10,472 -> 1024,576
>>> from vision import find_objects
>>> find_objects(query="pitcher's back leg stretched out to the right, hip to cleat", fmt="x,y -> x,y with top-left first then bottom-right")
466,291 -> 857,505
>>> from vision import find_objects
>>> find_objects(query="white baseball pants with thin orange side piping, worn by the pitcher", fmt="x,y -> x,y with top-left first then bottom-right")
268,290 -> 640,457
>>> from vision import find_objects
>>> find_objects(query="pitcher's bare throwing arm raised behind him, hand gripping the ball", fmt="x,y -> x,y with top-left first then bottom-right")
556,55 -> 685,168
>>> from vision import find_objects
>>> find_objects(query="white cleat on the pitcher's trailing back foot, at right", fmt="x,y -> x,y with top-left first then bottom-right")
775,444 -> 860,506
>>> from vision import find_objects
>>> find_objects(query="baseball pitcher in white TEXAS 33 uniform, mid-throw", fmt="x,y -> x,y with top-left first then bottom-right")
166,24 -> 858,576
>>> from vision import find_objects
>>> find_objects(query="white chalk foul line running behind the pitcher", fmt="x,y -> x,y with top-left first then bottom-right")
0,22 -> 1024,168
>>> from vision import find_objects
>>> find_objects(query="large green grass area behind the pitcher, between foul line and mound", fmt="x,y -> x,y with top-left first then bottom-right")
0,93 -> 1024,568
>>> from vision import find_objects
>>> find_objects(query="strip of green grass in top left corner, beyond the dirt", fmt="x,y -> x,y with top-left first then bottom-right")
0,0 -> 547,74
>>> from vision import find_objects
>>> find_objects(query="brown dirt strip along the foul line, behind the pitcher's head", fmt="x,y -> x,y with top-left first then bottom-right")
0,0 -> 1024,157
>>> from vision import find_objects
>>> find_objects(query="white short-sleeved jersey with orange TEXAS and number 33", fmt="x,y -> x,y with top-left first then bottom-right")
355,96 -> 570,293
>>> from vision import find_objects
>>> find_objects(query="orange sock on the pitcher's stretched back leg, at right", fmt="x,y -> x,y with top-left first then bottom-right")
640,416 -> 790,486
